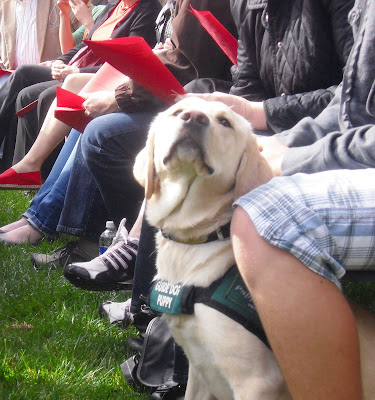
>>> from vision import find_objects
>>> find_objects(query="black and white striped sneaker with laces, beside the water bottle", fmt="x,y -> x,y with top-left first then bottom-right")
64,218 -> 139,291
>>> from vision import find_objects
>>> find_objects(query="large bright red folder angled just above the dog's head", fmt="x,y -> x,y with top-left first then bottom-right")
84,36 -> 186,104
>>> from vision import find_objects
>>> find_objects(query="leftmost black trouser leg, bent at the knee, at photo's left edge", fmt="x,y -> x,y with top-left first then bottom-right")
0,65 -> 56,172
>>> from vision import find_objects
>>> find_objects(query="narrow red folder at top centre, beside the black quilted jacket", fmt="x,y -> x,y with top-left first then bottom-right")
190,6 -> 238,66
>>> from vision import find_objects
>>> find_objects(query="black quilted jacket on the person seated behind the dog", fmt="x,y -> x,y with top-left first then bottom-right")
231,0 -> 354,132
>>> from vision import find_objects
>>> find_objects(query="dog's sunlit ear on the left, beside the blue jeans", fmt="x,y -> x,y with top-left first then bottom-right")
133,130 -> 156,200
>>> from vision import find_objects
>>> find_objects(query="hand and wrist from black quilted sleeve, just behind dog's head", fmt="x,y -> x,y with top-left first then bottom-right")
176,92 -> 267,131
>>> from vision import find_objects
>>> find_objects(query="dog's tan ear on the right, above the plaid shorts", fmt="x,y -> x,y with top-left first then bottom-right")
234,134 -> 273,200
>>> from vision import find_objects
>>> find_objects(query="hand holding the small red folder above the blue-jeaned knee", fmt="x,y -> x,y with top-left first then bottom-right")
79,91 -> 121,118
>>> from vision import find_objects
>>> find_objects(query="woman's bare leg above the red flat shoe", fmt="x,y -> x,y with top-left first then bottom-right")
12,74 -> 94,173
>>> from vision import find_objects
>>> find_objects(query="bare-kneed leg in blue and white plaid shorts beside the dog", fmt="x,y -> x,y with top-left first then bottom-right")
232,170 -> 375,400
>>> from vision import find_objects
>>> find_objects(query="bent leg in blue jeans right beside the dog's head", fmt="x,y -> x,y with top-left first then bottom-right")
58,113 -> 152,236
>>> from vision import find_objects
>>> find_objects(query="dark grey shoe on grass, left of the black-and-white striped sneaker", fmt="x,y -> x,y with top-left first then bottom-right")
31,241 -> 92,269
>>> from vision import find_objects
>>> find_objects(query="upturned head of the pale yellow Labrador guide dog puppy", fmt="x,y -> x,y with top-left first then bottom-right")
134,97 -> 272,238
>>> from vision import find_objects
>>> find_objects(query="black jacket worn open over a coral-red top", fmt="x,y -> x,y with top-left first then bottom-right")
58,0 -> 161,72
